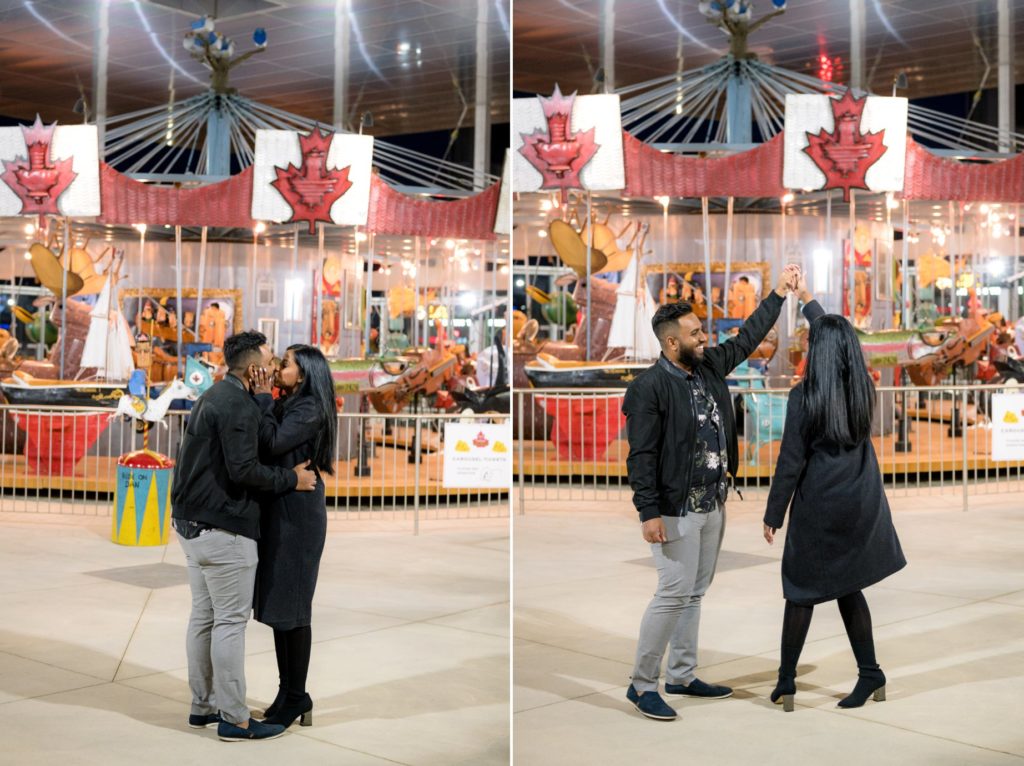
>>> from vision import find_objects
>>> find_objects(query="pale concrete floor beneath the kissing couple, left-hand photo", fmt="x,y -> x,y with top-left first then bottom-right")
0,507 -> 509,766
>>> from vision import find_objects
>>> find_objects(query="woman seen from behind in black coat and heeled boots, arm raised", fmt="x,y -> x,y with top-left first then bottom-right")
764,311 -> 906,712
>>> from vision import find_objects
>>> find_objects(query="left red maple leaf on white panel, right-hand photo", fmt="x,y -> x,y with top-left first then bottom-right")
519,85 -> 600,189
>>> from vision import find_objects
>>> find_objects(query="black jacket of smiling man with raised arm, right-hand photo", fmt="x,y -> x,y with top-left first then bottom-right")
623,290 -> 785,521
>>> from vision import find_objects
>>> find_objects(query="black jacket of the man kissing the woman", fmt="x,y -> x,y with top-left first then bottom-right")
171,375 -> 298,540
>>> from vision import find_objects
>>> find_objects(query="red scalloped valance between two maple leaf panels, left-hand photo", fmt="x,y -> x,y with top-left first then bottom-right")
99,163 -> 255,228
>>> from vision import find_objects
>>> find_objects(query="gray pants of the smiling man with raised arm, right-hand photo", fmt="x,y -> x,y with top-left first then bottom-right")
633,506 -> 725,693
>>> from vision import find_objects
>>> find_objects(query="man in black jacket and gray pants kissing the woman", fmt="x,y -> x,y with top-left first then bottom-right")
171,332 -> 316,741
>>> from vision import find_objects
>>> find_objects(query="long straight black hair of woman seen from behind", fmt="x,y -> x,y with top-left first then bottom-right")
803,314 -> 874,446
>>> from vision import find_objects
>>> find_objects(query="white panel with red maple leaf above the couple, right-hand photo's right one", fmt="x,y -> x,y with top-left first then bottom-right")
782,94 -> 907,193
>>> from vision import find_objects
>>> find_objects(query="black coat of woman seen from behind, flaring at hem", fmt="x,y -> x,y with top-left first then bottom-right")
764,305 -> 906,604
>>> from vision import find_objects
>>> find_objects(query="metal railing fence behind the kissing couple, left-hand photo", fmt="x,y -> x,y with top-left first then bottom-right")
0,405 -> 510,525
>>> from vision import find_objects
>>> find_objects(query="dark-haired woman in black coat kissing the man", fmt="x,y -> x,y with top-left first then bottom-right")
253,345 -> 338,727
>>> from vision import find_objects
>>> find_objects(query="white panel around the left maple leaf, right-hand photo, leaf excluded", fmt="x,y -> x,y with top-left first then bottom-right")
512,87 -> 626,192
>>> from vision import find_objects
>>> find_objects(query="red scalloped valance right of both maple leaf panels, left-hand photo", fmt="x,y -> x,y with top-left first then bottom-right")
367,175 -> 502,240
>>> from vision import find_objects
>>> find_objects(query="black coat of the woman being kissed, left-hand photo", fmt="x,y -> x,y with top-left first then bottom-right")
253,394 -> 327,630
